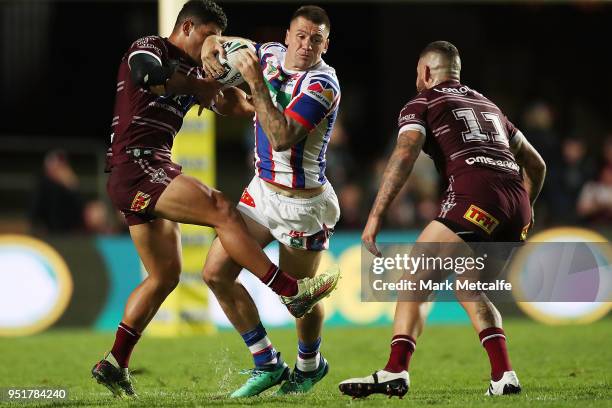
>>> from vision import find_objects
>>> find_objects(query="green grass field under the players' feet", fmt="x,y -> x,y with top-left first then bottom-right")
0,318 -> 612,407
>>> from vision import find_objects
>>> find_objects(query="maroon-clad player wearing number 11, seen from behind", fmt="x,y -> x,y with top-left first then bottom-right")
339,41 -> 546,397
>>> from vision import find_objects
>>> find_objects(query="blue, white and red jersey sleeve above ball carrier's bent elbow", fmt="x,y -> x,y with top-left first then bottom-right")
284,74 -> 340,130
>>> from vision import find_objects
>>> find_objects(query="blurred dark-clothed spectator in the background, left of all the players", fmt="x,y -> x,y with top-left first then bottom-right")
30,150 -> 83,234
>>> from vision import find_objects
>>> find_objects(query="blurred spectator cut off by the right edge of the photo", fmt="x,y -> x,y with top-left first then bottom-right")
578,136 -> 612,224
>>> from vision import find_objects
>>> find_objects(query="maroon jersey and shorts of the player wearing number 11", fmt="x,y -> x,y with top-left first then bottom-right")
398,80 -> 531,241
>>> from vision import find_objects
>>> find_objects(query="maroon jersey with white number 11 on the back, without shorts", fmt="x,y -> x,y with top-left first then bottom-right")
398,80 -> 522,180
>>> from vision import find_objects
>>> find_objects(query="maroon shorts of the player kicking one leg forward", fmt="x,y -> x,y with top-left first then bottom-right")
106,158 -> 181,225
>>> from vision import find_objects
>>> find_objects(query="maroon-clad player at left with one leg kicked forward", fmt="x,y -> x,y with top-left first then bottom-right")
92,0 -> 338,395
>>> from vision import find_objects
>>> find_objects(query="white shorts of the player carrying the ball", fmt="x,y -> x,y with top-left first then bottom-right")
238,176 -> 340,251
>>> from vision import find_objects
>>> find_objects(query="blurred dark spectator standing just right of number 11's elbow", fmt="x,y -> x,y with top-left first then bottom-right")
550,137 -> 595,224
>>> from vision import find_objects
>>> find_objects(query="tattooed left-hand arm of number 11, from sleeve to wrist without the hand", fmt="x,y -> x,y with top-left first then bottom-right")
371,131 -> 425,216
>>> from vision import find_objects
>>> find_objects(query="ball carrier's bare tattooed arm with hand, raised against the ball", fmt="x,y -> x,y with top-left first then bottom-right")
236,50 -> 308,152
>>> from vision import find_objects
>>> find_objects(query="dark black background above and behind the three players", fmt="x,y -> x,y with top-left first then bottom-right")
0,0 -> 612,233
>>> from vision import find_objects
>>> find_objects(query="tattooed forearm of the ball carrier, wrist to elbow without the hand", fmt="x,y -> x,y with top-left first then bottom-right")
252,80 -> 308,151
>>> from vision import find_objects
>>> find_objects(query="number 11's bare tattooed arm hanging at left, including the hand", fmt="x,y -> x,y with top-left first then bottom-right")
361,130 -> 425,256
